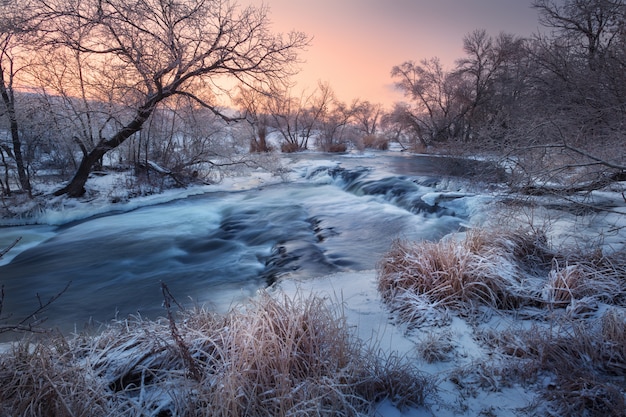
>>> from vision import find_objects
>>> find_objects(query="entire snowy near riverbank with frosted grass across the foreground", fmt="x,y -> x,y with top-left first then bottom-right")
0,230 -> 626,417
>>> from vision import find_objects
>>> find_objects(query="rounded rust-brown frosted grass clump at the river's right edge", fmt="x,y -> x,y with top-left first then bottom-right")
378,231 -> 521,316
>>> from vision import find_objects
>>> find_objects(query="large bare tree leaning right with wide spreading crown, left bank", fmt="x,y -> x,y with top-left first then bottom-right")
29,0 -> 308,197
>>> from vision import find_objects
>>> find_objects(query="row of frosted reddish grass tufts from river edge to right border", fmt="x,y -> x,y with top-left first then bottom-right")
378,230 -> 626,326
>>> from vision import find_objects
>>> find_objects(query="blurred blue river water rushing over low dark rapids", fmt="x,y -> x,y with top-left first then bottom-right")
0,154 -> 492,331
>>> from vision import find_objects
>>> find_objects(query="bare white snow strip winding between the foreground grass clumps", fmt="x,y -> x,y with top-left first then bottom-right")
275,271 -> 536,417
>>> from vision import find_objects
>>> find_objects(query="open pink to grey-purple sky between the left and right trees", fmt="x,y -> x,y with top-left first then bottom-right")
244,0 -> 539,107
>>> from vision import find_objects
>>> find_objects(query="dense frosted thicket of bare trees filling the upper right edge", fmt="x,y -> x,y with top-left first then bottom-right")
507,0 -> 626,195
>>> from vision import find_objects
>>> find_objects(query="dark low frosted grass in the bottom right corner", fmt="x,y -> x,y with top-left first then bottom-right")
494,309 -> 626,417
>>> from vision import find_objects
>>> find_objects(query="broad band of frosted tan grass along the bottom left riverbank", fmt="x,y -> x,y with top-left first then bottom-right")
0,294 -> 434,417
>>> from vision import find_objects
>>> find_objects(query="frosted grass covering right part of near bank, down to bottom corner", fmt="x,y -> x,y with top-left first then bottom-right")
377,229 -> 626,416
